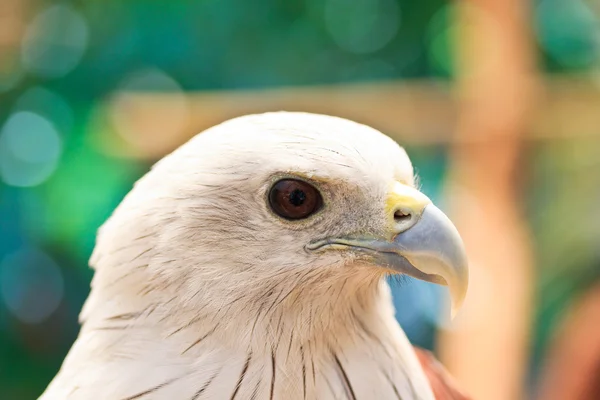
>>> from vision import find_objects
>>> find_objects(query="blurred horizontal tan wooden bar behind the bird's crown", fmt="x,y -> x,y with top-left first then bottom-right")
111,76 -> 600,158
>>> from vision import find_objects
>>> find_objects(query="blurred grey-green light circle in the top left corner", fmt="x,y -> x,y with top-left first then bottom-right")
22,4 -> 88,78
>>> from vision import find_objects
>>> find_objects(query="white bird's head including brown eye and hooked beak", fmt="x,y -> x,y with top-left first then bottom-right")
88,112 -> 468,328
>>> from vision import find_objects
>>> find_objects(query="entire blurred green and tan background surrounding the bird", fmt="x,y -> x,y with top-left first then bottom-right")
0,0 -> 600,400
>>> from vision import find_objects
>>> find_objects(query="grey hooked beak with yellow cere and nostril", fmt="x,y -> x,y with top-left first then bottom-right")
307,182 -> 469,316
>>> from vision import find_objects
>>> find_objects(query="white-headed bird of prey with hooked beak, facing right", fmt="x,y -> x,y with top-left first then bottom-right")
40,111 -> 468,400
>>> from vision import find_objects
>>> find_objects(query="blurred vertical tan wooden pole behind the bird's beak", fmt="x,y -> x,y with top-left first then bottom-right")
440,0 -> 535,400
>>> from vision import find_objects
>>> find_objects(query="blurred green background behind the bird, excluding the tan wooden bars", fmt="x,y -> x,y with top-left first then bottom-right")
0,0 -> 600,399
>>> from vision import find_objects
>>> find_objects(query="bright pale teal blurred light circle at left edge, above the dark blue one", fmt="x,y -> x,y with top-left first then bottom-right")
0,111 -> 61,186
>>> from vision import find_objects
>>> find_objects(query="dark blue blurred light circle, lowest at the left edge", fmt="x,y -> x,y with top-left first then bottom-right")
0,248 -> 64,324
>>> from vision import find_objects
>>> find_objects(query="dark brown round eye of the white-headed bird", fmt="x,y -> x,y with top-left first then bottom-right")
269,179 -> 323,220
